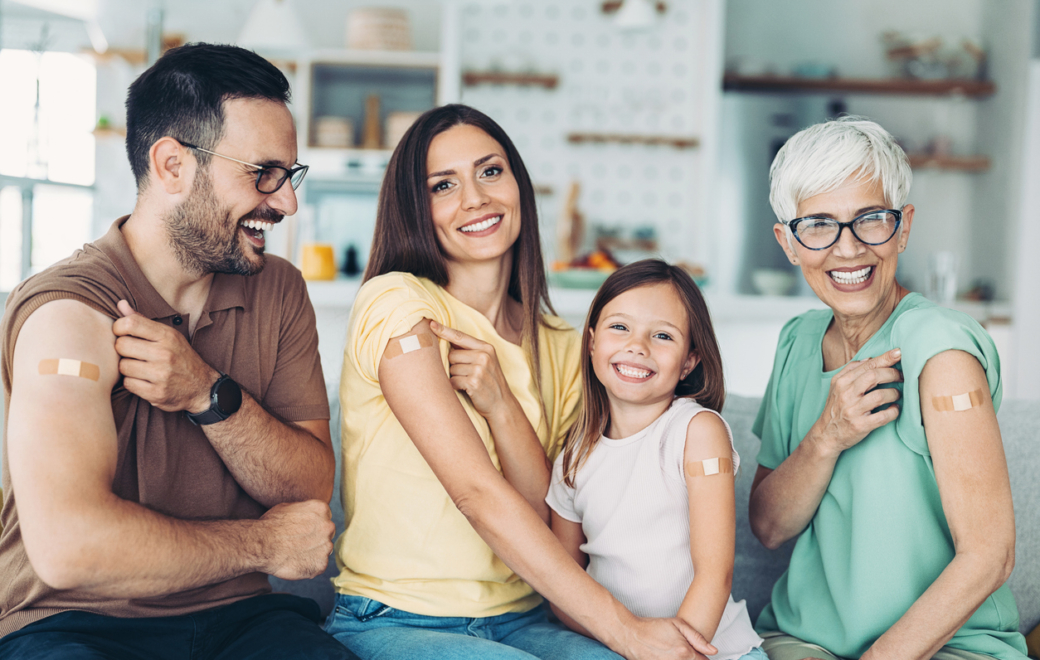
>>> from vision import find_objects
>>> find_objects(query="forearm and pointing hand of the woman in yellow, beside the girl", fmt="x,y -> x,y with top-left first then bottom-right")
430,321 -> 552,523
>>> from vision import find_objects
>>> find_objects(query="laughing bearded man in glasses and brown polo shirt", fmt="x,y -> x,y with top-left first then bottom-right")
0,44 -> 354,659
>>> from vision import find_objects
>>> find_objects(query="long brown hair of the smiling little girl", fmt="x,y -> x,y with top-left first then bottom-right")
564,259 -> 726,487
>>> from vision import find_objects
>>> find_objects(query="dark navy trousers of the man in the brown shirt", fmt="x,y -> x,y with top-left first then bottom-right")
0,593 -> 358,660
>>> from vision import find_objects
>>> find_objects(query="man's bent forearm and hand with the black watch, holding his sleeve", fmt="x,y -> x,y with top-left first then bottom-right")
112,300 -> 336,506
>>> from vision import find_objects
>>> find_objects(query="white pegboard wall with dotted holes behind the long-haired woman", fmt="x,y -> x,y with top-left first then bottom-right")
459,0 -> 719,260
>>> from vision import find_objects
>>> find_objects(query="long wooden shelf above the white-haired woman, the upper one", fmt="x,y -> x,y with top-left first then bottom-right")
722,75 -> 996,98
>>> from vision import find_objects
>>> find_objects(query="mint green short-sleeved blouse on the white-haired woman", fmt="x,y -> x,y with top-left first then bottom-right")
752,293 -> 1025,660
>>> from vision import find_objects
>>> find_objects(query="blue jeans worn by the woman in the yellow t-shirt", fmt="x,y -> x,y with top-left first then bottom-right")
326,593 -> 622,660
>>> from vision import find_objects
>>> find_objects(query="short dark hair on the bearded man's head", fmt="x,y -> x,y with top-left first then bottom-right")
127,44 -> 291,190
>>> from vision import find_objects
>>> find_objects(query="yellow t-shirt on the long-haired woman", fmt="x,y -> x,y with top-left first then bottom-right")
333,272 -> 581,617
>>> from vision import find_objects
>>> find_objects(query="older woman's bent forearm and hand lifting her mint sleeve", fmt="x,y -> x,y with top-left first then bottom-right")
749,350 -> 902,550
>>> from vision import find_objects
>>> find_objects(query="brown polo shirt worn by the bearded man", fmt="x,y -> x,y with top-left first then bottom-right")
0,217 -> 329,637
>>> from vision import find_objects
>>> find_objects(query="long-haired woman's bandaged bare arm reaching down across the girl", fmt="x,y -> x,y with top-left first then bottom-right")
379,320 -> 713,659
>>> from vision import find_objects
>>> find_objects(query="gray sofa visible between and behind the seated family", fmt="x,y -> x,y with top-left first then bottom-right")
271,387 -> 1040,633
